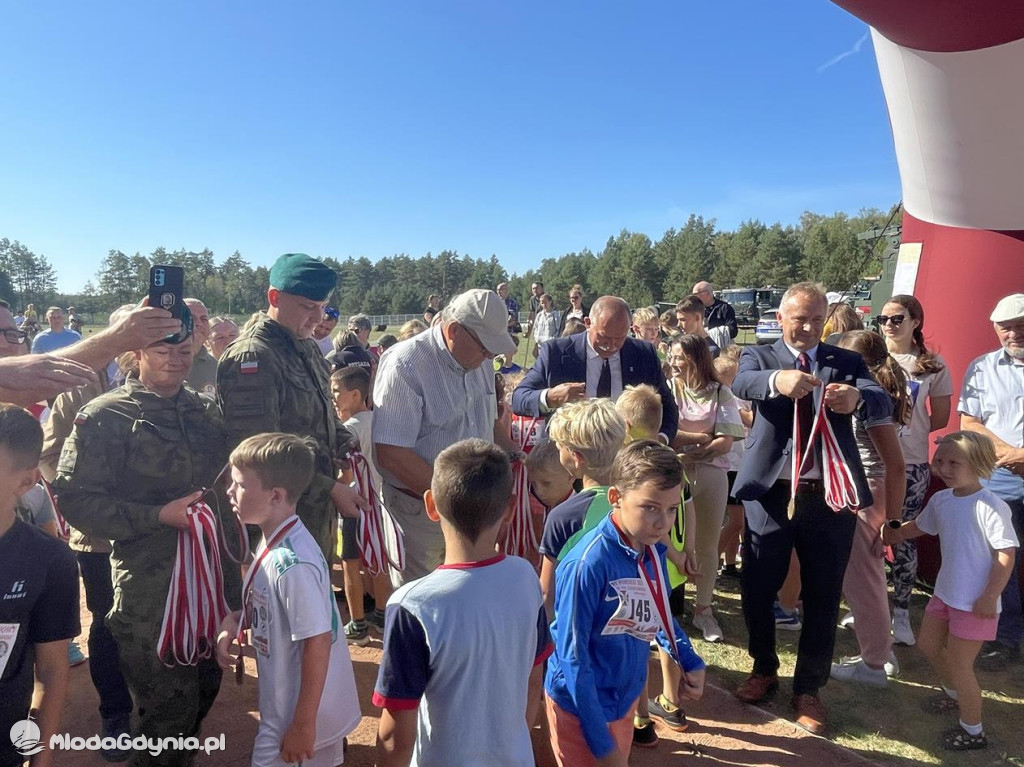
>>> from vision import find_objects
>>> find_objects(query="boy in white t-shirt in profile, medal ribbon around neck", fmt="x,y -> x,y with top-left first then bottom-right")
217,433 -> 361,767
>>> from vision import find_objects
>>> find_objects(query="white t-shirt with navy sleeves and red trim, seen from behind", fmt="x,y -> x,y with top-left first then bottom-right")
373,554 -> 553,767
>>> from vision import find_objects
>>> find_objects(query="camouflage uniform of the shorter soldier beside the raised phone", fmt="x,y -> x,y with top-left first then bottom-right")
54,378 -> 241,765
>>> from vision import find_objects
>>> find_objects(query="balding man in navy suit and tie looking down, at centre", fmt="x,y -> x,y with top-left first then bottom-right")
512,296 -> 679,444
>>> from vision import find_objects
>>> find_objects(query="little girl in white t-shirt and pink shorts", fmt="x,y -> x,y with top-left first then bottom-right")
882,431 -> 1019,751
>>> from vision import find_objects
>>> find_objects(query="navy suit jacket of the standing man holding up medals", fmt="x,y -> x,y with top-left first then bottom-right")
732,340 -> 893,507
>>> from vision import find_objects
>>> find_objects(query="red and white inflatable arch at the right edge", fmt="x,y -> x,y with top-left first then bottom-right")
834,0 -> 1024,397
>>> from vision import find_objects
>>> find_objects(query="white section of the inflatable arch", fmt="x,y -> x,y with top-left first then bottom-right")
871,29 -> 1024,229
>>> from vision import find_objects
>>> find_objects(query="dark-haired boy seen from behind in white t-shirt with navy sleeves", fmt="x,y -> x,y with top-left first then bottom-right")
373,439 -> 552,767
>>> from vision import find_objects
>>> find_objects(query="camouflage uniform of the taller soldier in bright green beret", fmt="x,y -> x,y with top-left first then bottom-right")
217,312 -> 355,562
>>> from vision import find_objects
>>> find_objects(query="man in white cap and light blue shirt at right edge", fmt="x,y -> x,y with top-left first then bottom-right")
957,293 -> 1024,671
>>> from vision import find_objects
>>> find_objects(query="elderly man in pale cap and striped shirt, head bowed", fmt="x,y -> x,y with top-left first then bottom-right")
373,290 -> 516,588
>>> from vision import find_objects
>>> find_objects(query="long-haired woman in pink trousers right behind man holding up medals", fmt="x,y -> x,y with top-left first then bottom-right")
831,330 -> 910,687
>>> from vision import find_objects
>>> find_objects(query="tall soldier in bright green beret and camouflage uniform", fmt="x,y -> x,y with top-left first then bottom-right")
217,253 -> 365,563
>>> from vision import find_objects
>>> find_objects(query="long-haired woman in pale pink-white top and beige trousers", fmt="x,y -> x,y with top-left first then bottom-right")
669,334 -> 743,642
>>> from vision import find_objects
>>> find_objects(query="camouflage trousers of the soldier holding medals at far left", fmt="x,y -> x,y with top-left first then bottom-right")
108,614 -> 222,767
